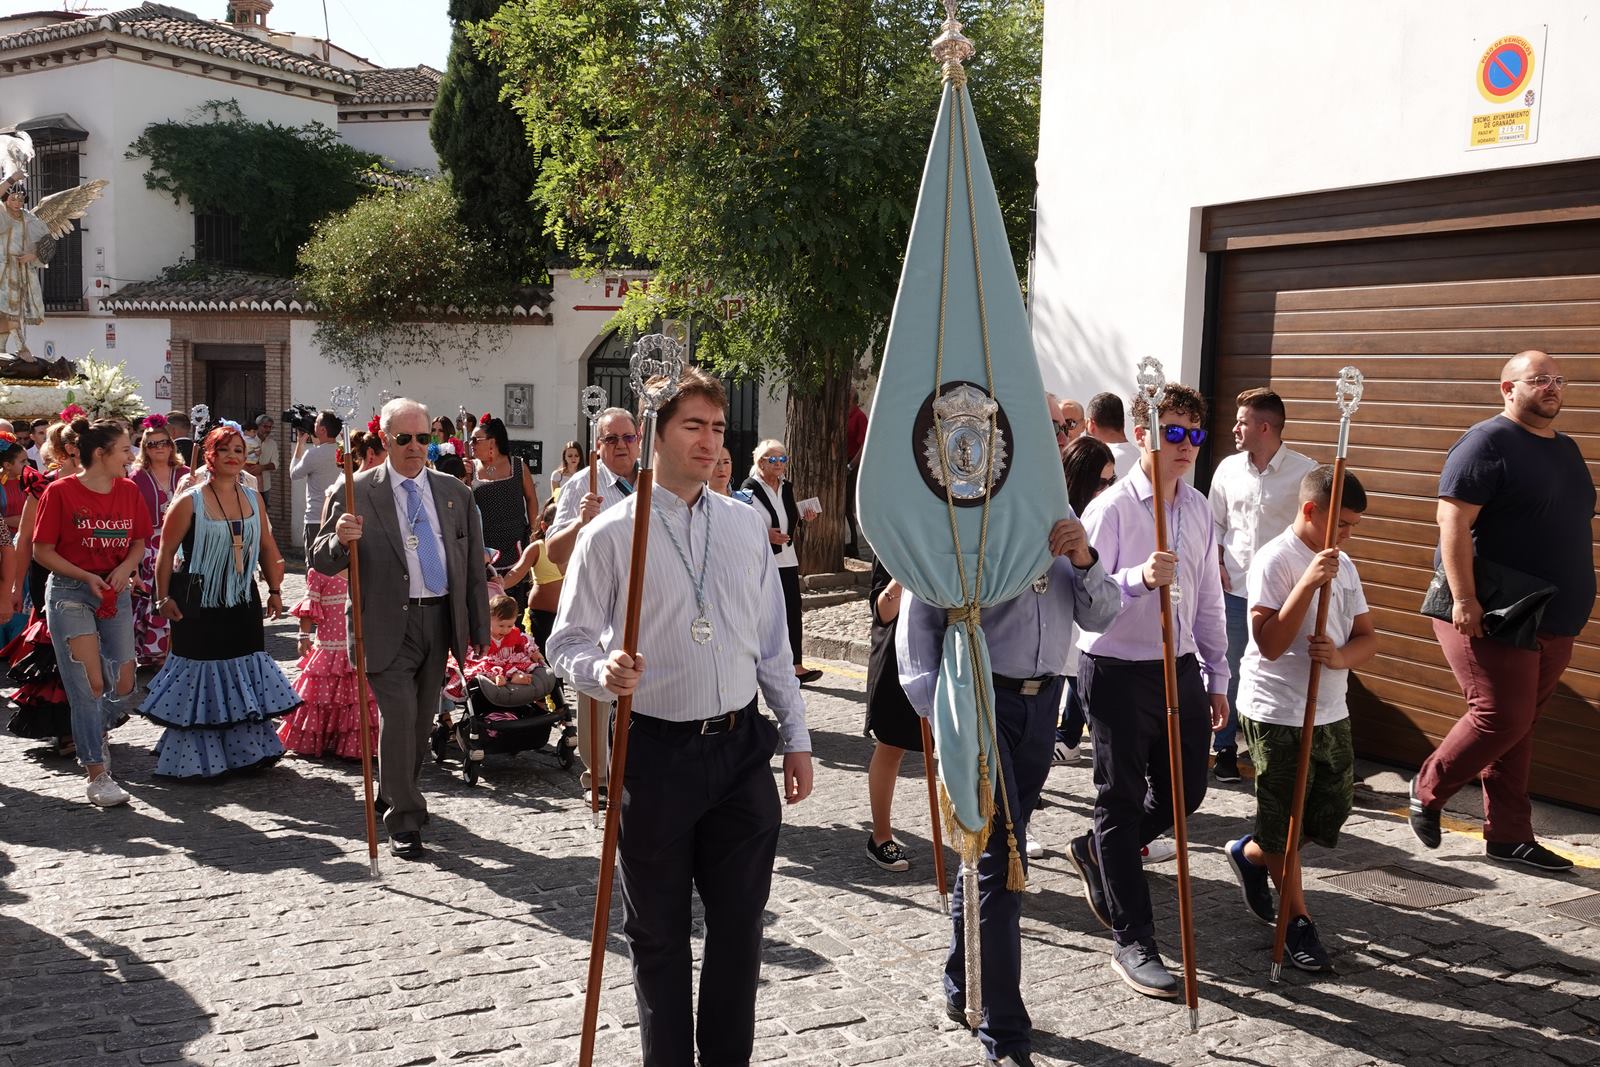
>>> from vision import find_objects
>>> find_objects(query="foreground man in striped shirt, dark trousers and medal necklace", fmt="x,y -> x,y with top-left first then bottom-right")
549,368 -> 811,1067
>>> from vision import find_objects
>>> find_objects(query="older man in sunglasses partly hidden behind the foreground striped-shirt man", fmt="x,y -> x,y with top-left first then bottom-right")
546,408 -> 638,805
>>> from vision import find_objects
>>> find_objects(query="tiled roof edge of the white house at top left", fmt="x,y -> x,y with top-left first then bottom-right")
0,3 -> 360,88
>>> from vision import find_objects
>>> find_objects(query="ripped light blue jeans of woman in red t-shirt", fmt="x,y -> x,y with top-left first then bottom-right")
45,574 -> 133,766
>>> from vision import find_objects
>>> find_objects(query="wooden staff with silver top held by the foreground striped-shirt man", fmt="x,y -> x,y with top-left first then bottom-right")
578,333 -> 688,1067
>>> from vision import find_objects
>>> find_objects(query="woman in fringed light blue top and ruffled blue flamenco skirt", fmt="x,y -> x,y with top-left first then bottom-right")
139,422 -> 301,777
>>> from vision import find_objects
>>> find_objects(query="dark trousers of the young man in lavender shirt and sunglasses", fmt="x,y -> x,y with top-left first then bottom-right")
1078,653 -> 1211,945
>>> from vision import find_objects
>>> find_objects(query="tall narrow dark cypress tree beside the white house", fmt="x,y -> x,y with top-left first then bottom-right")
429,0 -> 549,285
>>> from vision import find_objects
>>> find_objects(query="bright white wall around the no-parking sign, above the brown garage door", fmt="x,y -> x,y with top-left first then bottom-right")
1030,0 -> 1600,400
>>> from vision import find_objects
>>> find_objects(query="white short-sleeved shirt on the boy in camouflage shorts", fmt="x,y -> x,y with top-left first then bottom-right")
1238,530 -> 1366,726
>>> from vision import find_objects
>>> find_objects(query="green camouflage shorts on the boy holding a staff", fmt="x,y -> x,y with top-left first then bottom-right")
1240,718 -> 1355,853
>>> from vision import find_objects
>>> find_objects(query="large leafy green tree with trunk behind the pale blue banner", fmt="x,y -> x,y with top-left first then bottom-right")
469,0 -> 1043,571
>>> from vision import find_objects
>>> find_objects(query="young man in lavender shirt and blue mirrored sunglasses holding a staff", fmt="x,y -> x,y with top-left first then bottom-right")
1069,386 -> 1229,997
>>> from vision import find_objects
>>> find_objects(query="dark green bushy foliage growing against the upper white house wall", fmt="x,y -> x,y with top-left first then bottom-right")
128,101 -> 381,275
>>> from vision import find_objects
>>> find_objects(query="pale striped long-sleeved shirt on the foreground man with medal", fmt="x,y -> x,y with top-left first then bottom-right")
546,489 -> 811,752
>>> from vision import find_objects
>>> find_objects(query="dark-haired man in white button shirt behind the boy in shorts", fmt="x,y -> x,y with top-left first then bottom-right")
1208,389 -> 1317,782
